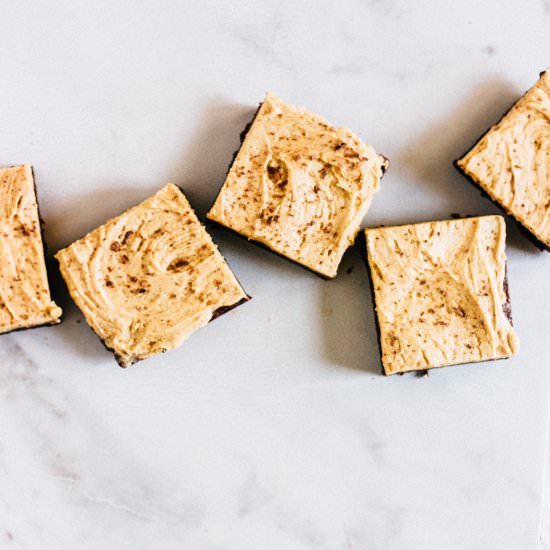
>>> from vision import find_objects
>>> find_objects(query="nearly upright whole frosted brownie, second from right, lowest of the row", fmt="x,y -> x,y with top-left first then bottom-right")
365,216 -> 519,374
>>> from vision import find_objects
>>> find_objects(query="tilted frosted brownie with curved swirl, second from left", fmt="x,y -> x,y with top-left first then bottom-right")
55,184 -> 249,367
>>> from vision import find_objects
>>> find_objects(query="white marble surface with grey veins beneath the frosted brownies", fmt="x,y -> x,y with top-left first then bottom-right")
0,0 -> 550,550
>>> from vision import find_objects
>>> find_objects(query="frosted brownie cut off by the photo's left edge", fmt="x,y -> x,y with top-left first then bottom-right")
0,165 -> 62,333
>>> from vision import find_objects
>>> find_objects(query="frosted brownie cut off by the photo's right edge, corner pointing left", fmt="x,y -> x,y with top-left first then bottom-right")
455,71 -> 550,250
